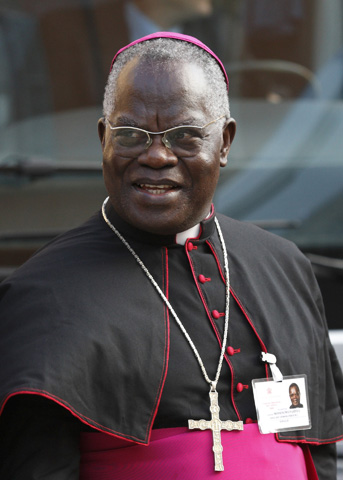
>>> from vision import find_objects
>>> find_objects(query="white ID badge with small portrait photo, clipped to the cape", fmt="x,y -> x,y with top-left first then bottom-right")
252,375 -> 311,433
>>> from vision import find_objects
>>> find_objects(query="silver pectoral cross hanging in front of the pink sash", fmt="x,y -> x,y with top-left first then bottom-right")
188,388 -> 243,472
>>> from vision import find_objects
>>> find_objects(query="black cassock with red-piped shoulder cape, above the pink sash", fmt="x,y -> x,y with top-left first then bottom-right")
0,203 -> 343,480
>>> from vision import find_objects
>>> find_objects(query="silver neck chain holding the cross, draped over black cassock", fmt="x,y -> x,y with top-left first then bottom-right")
102,197 -> 230,390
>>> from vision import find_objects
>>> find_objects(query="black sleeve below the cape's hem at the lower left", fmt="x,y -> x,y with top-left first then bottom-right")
0,395 -> 84,480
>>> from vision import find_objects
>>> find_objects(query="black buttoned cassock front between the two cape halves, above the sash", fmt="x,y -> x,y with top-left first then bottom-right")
154,242 -> 266,428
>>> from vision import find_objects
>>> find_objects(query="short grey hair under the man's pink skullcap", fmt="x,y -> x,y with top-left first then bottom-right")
103,38 -> 230,118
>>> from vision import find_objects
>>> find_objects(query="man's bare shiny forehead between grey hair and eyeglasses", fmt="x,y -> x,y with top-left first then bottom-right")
111,58 -> 209,123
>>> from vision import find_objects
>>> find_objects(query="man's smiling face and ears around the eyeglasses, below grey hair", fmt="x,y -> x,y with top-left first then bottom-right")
99,59 -> 235,235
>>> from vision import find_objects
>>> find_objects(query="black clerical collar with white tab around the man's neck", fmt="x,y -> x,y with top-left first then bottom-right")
106,202 -> 215,247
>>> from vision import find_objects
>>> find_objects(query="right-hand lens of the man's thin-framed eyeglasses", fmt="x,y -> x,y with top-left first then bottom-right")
165,127 -> 203,154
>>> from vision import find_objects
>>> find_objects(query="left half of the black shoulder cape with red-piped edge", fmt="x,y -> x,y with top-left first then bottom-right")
0,210 -> 168,442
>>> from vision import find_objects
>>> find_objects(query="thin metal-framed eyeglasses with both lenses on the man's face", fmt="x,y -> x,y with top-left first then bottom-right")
106,115 -> 225,156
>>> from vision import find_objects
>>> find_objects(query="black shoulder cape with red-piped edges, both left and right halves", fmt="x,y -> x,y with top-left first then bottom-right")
0,214 -> 343,444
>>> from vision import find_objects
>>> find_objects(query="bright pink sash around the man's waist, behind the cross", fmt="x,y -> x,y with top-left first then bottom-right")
80,424 -> 318,480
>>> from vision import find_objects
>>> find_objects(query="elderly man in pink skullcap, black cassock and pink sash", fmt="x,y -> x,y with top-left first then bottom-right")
0,33 -> 342,480
